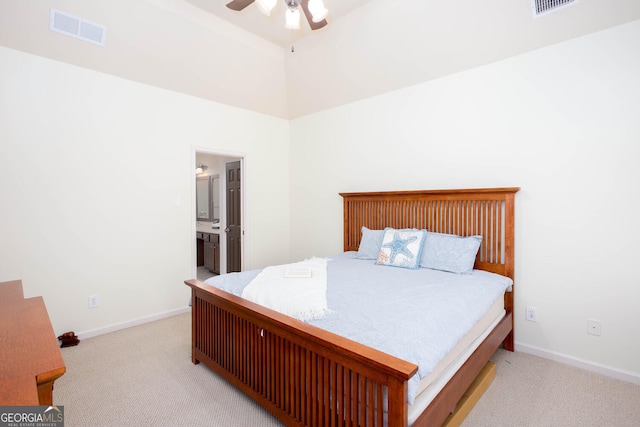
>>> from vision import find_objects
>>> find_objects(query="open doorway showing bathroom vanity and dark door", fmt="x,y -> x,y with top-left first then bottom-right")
192,151 -> 245,281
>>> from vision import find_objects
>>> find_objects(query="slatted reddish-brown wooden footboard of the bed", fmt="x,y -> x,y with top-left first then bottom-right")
185,280 -> 418,426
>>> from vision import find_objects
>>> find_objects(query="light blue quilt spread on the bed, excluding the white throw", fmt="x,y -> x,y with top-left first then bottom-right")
206,252 -> 512,403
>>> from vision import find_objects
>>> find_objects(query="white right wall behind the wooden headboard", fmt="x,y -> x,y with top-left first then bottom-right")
291,21 -> 640,379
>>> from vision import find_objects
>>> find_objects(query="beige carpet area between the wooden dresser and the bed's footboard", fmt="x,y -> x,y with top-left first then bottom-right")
53,314 -> 281,427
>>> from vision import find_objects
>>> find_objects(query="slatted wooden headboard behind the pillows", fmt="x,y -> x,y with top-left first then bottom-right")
340,187 -> 519,279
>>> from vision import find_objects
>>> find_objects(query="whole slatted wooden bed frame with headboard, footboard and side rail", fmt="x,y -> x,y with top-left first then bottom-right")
185,188 -> 518,427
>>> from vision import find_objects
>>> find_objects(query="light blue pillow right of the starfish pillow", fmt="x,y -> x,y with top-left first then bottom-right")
420,231 -> 482,274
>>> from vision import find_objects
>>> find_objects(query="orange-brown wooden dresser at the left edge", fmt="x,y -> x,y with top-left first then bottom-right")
0,280 -> 67,406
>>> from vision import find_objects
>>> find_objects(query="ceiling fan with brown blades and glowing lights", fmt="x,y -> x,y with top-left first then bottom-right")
227,0 -> 328,30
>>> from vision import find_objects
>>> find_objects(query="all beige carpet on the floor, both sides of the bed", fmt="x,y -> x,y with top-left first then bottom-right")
53,315 -> 640,427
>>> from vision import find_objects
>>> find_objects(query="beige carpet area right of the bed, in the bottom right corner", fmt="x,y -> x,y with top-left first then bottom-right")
462,350 -> 640,427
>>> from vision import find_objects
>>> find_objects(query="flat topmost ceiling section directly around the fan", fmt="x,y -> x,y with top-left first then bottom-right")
185,0 -> 370,47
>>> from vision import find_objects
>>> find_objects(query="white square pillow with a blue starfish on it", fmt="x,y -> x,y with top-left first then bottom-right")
376,228 -> 425,269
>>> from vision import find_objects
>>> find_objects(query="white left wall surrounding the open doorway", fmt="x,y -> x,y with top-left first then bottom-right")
0,47 -> 289,333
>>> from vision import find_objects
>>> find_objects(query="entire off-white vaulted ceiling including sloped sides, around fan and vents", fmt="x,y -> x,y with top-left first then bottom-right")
0,0 -> 640,119
